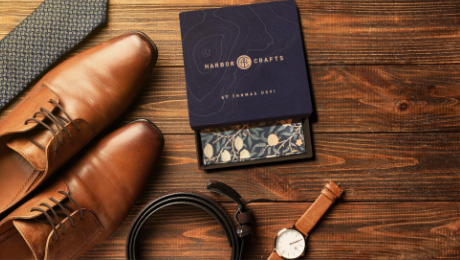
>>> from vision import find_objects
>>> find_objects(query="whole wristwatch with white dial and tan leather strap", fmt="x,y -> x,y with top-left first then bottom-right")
268,181 -> 343,260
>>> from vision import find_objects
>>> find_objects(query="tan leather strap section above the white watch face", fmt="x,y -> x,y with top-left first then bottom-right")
294,181 -> 342,236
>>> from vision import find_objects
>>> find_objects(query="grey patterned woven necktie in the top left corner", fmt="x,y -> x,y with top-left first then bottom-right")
0,0 -> 107,109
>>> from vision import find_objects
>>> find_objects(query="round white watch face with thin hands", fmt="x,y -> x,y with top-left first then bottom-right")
275,228 -> 305,259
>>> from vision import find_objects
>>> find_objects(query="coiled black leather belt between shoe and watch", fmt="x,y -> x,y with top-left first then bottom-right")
126,181 -> 253,260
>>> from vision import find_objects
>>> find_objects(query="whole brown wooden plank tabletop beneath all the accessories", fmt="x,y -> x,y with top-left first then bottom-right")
0,0 -> 460,259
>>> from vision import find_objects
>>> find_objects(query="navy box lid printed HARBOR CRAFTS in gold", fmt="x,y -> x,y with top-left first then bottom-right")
179,0 -> 312,130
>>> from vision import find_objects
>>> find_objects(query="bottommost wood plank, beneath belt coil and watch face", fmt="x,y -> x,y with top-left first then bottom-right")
81,201 -> 460,260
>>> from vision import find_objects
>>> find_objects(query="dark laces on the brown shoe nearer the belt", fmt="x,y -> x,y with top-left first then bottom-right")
30,191 -> 85,240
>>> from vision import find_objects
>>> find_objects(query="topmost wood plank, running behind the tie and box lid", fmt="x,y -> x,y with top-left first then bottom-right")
0,0 -> 460,66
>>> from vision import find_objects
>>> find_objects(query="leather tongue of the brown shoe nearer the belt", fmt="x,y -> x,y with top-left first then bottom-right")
13,220 -> 52,259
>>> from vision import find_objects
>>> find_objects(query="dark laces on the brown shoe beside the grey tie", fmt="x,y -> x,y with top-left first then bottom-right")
24,99 -> 80,152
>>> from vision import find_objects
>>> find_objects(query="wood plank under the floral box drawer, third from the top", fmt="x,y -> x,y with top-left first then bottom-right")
127,133 -> 460,203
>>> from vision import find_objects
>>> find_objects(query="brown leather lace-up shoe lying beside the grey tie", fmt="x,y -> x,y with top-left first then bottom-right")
0,33 -> 157,216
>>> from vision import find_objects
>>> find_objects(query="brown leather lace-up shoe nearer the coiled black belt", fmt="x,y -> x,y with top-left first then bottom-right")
0,120 -> 163,259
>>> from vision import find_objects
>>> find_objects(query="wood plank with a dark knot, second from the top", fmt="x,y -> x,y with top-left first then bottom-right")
116,65 -> 460,134
